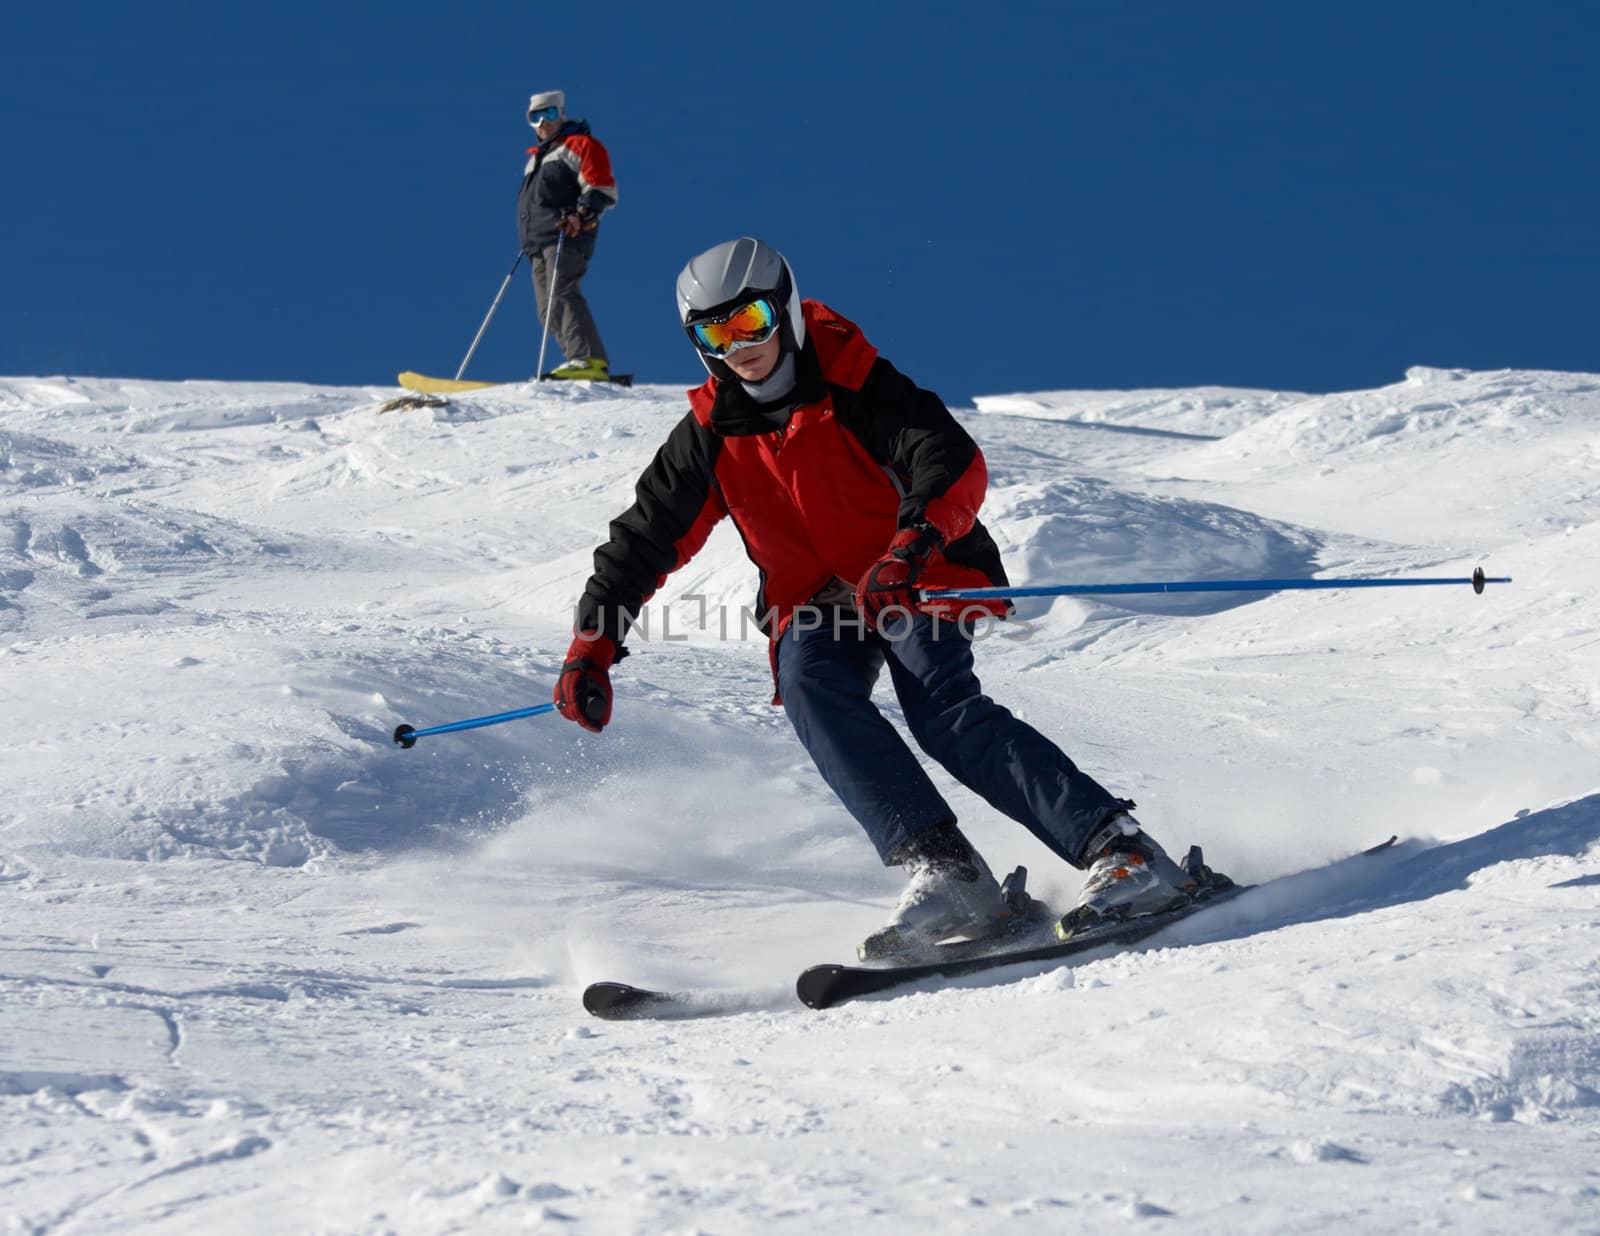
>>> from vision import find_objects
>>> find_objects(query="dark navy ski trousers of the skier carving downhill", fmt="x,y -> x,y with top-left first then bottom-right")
778,612 -> 1126,865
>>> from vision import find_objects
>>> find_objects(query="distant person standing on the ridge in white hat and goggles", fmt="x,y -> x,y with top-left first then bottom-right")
517,90 -> 616,379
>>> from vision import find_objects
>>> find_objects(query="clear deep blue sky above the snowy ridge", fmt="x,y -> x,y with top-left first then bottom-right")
0,0 -> 1600,400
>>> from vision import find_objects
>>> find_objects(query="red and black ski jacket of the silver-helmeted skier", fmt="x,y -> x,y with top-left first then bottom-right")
578,301 -> 1006,644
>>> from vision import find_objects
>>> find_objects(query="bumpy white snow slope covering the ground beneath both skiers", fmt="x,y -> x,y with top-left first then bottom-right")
0,368 -> 1600,1236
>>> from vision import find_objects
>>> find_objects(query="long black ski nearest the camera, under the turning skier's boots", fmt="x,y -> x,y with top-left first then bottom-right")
795,837 -> 1398,1009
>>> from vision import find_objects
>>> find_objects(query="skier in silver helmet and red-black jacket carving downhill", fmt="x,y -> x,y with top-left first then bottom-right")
555,237 -> 1192,957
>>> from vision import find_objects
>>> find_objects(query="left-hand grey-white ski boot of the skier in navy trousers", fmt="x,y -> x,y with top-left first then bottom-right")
856,821 -> 1011,961
